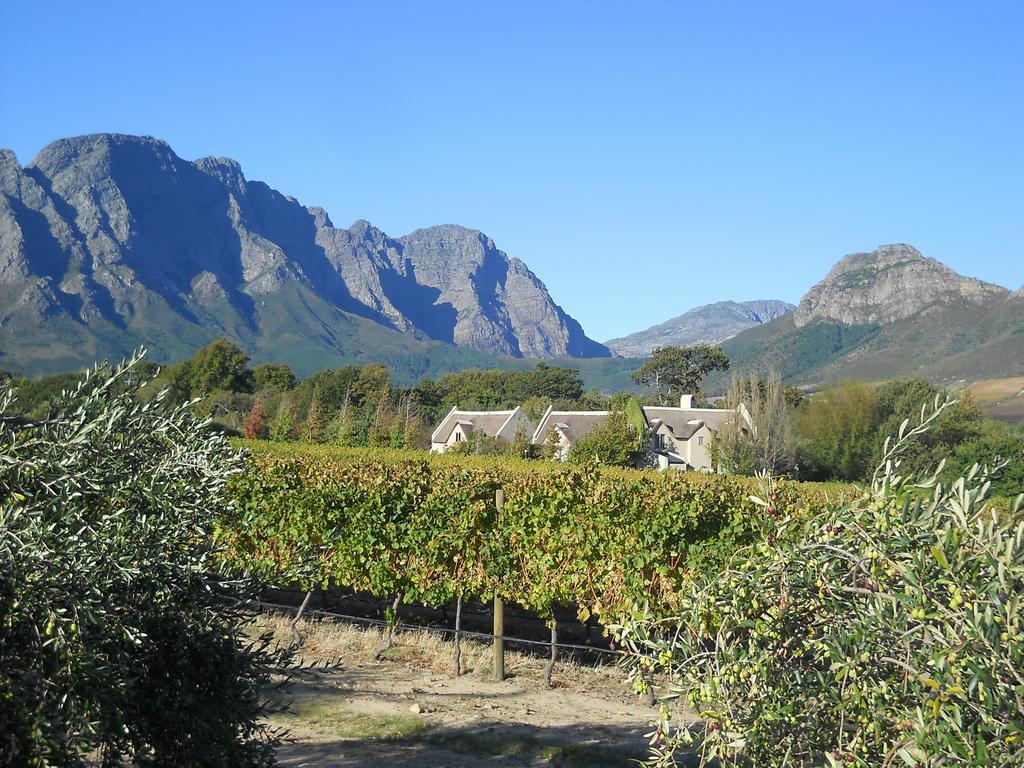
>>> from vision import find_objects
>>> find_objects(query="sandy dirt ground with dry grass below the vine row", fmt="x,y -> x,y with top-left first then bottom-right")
261,616 -> 692,768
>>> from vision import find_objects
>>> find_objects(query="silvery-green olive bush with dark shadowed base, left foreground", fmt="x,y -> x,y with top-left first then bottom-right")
0,360 -> 287,768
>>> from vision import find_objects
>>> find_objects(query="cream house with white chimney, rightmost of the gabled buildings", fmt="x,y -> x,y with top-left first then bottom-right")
641,394 -> 751,472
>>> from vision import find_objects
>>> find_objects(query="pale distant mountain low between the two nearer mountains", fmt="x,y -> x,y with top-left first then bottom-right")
604,299 -> 796,357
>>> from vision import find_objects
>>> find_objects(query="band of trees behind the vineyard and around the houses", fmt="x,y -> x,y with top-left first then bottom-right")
7,339 -> 1024,496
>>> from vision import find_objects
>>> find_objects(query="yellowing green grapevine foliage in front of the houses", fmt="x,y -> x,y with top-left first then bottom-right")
217,441 -> 859,621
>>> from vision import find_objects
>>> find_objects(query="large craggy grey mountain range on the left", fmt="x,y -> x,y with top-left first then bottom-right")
0,134 -> 609,380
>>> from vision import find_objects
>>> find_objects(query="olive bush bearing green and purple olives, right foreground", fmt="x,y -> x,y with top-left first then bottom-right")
615,404 -> 1024,768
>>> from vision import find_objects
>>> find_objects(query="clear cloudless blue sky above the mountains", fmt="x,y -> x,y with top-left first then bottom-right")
0,0 -> 1024,340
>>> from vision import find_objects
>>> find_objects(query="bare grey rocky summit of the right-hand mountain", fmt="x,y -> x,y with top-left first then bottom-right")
793,244 -> 1010,328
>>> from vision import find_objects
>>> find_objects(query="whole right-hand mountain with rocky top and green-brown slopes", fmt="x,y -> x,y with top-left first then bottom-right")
709,245 -> 1024,389
